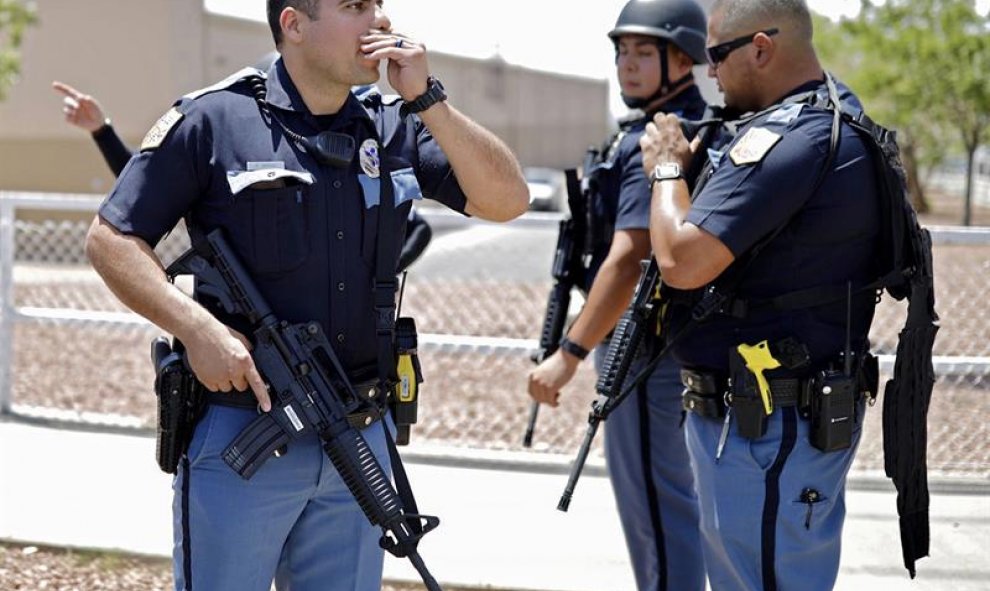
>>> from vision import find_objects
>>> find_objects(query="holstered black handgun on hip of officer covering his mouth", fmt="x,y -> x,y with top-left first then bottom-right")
151,337 -> 205,474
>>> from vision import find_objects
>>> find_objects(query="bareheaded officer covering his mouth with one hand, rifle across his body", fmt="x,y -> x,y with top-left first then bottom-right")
87,0 -> 528,591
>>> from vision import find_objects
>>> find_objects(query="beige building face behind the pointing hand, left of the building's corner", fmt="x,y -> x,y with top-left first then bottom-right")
0,0 -> 203,192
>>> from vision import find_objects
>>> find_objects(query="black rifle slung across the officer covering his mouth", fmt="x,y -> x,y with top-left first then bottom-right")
166,230 -> 440,591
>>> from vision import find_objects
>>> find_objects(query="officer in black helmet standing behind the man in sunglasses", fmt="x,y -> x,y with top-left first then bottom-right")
529,0 -> 705,591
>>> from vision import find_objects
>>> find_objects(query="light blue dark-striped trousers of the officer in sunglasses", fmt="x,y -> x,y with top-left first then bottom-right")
687,404 -> 863,591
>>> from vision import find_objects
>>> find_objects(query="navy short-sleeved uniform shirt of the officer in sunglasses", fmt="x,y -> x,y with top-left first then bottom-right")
668,82 -> 880,371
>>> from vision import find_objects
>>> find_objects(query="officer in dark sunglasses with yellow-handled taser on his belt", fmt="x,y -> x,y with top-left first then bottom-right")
640,0 -> 879,590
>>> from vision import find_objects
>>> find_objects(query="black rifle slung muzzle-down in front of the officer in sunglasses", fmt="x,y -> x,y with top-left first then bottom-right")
557,114 -> 724,511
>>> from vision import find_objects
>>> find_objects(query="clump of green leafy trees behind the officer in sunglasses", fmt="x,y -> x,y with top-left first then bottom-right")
816,0 -> 990,225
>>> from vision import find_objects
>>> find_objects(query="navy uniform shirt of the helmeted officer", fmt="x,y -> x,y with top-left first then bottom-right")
585,86 -> 707,290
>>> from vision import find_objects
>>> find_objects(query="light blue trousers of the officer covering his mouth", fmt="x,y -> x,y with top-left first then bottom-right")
172,405 -> 390,591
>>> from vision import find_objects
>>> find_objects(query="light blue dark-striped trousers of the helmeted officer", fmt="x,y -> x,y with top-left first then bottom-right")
595,346 -> 705,591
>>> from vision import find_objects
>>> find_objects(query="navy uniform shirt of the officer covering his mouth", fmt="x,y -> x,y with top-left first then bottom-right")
100,59 -> 466,370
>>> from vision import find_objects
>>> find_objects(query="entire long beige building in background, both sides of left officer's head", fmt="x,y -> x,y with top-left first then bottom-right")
0,0 -> 609,193
